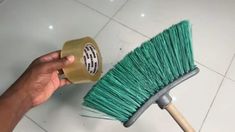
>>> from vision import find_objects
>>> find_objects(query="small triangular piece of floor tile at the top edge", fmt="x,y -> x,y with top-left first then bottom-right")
77,0 -> 127,17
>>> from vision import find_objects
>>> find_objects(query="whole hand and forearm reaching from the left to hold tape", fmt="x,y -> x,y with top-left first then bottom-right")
0,51 -> 74,132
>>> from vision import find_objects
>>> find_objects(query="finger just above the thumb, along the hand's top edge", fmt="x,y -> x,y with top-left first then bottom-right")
39,50 -> 61,62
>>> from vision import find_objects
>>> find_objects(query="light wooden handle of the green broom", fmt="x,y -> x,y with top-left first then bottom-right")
165,103 -> 195,132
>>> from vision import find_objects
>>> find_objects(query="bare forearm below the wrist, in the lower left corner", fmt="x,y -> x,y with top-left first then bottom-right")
0,87 -> 32,132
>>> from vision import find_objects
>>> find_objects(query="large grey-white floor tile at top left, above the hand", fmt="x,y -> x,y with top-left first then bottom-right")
0,0 -> 108,93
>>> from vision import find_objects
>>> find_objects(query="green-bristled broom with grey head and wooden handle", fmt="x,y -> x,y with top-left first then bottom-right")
83,20 -> 199,132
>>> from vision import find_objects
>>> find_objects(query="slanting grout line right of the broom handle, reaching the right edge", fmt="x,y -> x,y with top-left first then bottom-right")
199,55 -> 235,132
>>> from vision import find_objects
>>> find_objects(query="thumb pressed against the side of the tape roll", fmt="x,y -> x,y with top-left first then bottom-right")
45,55 -> 75,72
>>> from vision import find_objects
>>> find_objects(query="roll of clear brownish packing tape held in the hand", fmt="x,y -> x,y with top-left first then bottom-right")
61,37 -> 102,83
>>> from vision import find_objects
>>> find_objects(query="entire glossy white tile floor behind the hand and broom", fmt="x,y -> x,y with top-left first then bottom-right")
0,0 -> 235,132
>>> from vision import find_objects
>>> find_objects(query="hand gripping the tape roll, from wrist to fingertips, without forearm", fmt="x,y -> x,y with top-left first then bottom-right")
11,51 -> 74,107
